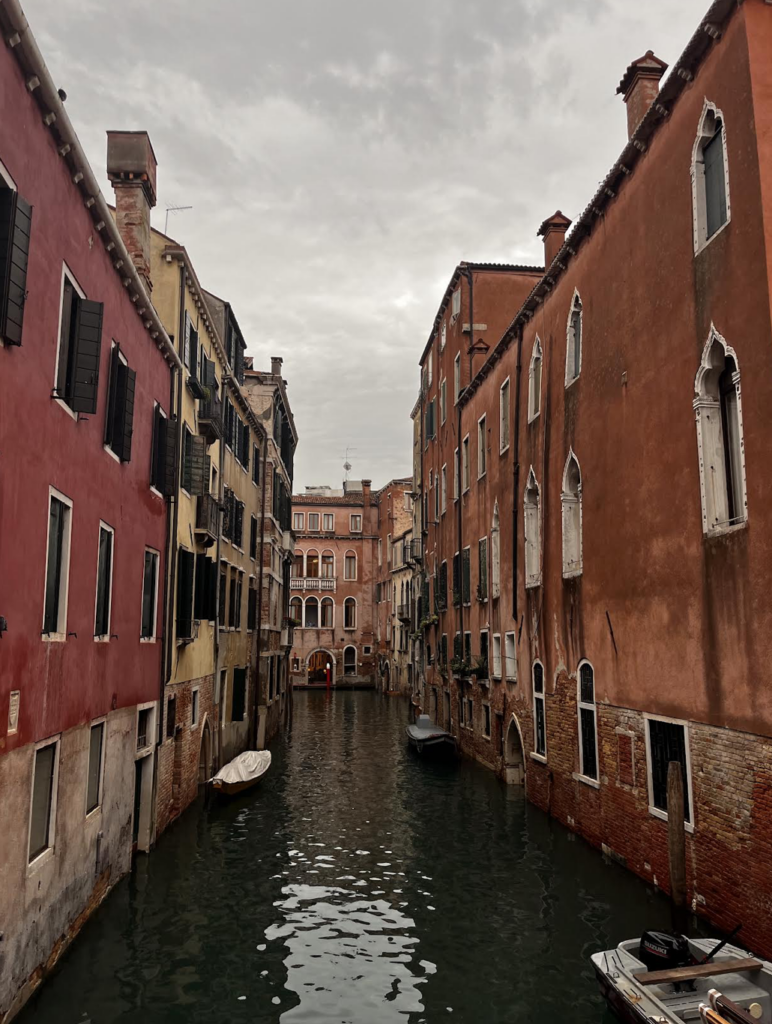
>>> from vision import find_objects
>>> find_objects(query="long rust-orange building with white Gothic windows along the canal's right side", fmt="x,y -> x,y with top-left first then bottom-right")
411,0 -> 772,953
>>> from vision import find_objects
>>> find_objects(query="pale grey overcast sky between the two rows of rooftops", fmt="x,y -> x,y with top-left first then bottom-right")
25,0 -> 709,490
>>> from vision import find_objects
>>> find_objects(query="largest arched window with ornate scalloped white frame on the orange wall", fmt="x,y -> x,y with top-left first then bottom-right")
694,327 -> 747,534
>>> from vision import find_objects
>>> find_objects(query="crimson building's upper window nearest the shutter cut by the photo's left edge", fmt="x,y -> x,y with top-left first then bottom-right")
54,272 -> 102,416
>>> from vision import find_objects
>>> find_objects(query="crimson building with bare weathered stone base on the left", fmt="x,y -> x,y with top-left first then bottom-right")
0,8 -> 178,1017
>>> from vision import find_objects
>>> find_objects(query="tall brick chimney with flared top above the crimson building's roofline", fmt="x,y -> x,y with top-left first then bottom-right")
108,131 -> 158,290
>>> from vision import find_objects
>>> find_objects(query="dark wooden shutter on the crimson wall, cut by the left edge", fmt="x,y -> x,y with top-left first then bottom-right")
0,188 -> 32,345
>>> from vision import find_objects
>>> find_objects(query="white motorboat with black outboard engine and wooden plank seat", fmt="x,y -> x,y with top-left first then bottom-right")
591,931 -> 772,1024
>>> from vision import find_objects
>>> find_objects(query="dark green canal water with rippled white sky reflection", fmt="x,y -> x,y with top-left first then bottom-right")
20,692 -> 683,1024
